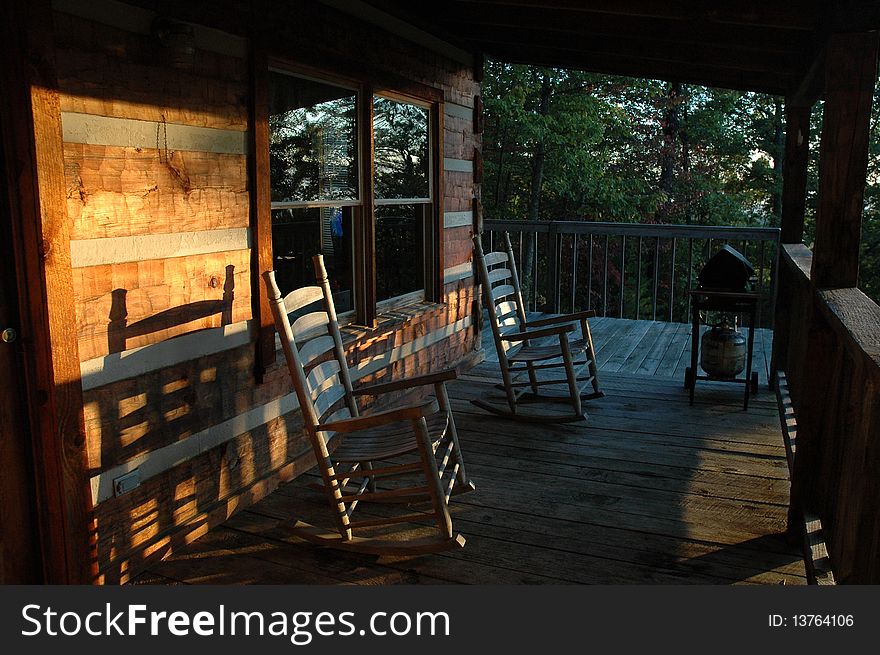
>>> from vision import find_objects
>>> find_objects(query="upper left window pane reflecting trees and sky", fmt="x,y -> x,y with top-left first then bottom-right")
269,72 -> 358,202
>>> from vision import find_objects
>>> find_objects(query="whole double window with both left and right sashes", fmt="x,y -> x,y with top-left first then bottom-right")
268,70 -> 439,324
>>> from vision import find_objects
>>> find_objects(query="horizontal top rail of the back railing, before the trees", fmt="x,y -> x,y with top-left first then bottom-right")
483,219 -> 780,241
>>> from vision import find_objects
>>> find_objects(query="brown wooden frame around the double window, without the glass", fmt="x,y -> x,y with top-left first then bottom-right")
250,50 -> 445,371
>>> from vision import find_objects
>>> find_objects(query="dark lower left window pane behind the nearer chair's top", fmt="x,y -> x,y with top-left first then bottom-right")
272,207 -> 354,314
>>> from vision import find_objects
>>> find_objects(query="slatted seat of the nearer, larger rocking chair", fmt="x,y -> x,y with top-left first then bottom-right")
333,412 -> 449,463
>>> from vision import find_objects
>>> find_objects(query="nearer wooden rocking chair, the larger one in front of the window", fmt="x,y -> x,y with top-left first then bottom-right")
264,255 -> 474,555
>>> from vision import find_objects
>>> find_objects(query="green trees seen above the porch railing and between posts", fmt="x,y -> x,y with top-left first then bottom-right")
483,61 -> 880,299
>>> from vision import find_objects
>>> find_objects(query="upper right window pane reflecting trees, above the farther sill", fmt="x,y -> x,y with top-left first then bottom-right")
373,98 -> 430,199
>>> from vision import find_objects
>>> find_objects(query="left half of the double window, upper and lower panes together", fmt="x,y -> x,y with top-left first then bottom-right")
269,72 -> 360,313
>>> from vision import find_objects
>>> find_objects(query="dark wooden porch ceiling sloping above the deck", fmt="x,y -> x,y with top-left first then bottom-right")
360,0 -> 880,95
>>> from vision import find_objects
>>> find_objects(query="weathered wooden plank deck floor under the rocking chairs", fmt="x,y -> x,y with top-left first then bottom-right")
137,319 -> 805,584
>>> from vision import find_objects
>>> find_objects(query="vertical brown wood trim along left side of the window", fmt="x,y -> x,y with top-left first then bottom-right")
249,44 -> 275,380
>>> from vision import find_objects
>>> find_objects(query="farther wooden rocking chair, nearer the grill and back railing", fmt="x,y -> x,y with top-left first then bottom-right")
471,232 -> 605,423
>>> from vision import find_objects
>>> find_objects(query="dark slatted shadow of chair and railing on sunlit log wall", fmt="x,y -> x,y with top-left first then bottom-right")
75,265 -> 310,584
